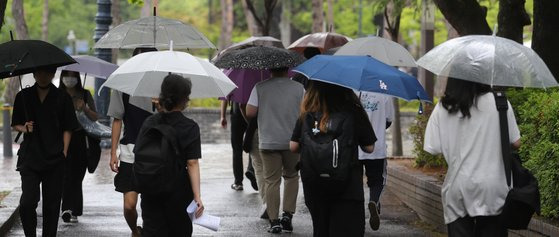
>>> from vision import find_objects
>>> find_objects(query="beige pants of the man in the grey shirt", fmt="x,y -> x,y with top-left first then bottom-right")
260,150 -> 299,220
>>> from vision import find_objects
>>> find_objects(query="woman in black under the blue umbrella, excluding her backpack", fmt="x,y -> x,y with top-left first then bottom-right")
290,80 -> 377,237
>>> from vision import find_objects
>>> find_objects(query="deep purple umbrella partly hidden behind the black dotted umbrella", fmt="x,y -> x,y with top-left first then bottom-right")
224,69 -> 270,104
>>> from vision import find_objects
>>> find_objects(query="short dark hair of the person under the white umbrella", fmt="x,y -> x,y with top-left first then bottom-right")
159,74 -> 192,111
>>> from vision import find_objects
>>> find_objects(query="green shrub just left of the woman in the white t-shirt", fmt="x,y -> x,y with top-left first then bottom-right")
409,106 -> 446,167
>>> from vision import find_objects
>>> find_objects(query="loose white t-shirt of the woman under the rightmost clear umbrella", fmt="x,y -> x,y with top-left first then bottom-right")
423,93 -> 520,224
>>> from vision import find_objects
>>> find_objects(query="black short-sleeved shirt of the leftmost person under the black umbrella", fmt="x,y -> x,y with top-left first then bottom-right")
12,84 -> 79,170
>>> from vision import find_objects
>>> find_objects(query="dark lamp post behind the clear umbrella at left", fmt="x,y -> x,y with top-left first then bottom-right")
93,0 -> 112,125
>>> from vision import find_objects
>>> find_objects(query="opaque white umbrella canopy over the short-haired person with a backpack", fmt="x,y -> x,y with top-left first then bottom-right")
101,51 -> 236,98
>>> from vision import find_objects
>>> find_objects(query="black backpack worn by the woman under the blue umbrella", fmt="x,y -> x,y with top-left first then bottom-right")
300,113 -> 357,194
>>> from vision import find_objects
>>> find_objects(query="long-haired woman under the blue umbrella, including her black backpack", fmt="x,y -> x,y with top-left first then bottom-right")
290,80 -> 376,237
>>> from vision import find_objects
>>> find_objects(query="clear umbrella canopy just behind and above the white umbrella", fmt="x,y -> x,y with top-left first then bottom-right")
94,16 -> 216,49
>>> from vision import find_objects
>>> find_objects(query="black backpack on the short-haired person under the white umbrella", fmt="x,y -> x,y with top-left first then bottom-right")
133,119 -> 185,195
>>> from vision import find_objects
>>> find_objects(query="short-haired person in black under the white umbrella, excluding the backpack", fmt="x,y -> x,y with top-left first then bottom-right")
138,74 -> 204,237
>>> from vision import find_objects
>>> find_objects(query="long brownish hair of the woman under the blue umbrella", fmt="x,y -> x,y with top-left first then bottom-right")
300,80 -> 365,132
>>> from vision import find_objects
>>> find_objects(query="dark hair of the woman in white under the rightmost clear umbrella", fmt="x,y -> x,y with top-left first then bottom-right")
441,77 -> 492,118
